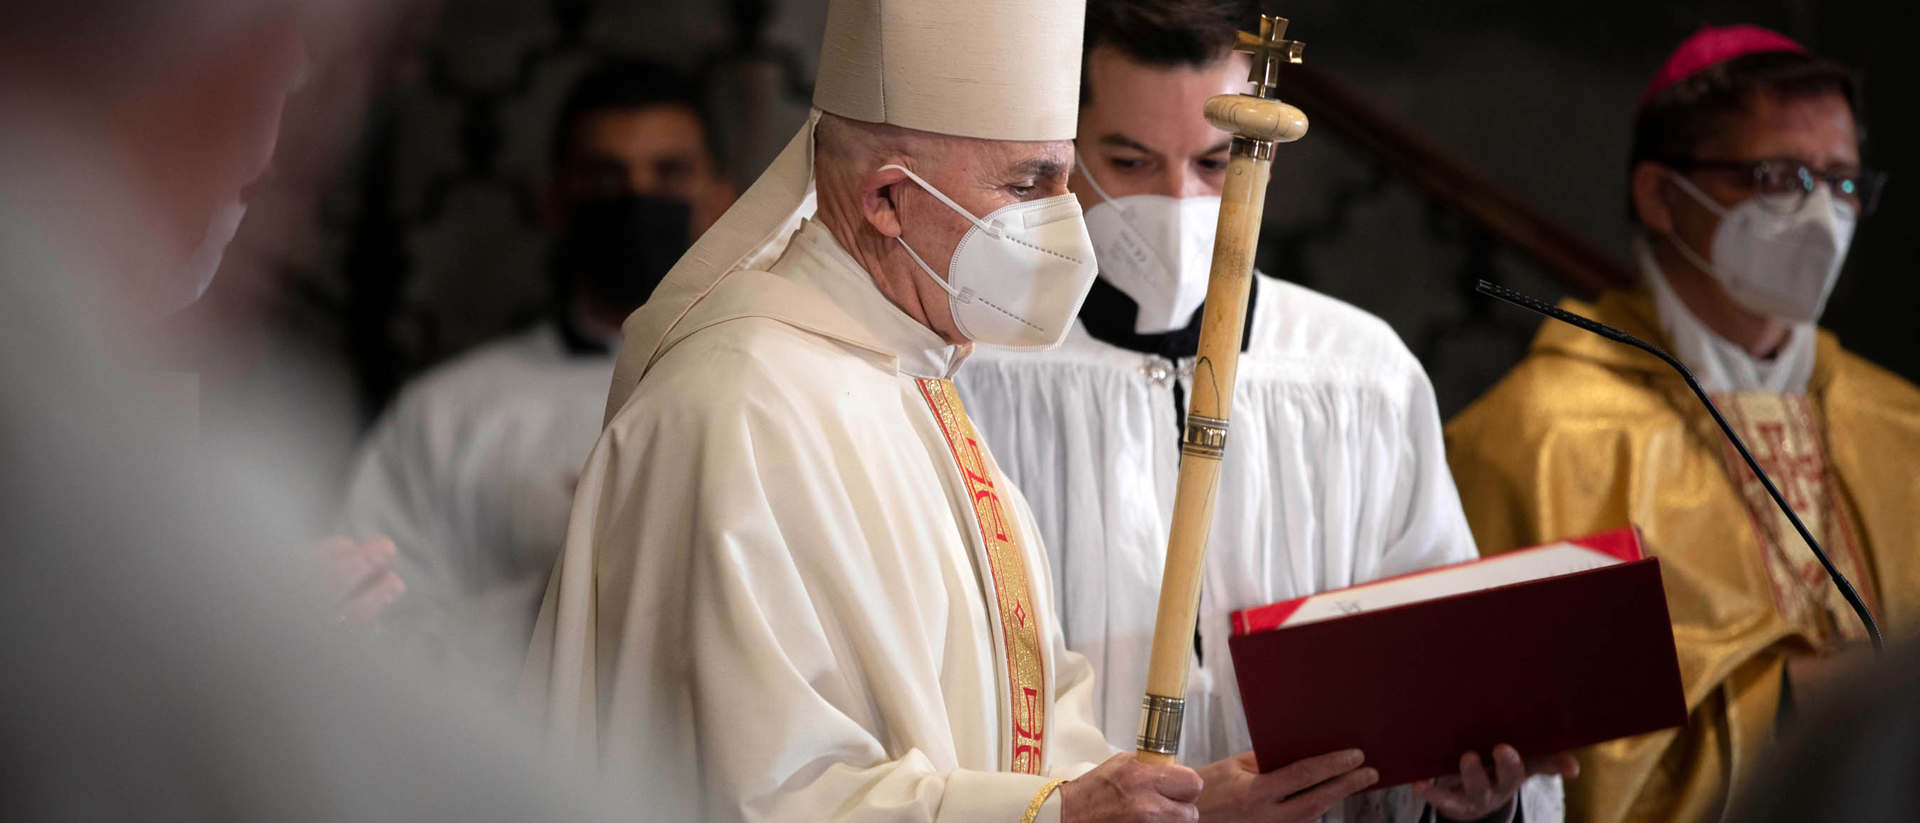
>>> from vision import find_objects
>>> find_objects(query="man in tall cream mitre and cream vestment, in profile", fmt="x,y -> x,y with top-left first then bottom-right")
522,0 -> 1373,823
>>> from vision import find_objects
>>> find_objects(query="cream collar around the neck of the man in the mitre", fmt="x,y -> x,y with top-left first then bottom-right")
772,219 -> 973,378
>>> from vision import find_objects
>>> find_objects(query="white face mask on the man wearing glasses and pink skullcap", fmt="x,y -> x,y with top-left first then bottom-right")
1670,173 -> 1859,322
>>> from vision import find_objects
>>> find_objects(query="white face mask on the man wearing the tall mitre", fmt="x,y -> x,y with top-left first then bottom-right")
881,165 -> 1098,349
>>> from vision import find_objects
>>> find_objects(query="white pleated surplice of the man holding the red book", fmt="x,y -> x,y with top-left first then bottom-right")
954,274 -> 1559,821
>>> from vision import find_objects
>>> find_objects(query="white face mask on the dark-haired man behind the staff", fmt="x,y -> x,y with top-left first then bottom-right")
1073,155 -> 1219,334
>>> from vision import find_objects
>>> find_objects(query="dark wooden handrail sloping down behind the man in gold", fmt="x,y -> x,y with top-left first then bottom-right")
1279,63 -> 1634,297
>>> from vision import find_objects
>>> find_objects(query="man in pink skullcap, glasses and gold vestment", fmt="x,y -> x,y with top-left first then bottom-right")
1448,25 -> 1920,823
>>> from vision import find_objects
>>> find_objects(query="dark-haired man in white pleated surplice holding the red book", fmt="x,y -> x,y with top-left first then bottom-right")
956,0 -> 1571,823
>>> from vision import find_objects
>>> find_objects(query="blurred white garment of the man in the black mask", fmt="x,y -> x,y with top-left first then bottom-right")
340,322 -> 612,698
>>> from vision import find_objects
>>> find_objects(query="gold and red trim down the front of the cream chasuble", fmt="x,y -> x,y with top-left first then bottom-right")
918,380 -> 1048,775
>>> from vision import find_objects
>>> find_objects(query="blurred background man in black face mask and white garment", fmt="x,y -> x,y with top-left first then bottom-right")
340,59 -> 733,696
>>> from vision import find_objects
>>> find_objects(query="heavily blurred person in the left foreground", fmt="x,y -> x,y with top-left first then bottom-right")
0,0 -> 625,821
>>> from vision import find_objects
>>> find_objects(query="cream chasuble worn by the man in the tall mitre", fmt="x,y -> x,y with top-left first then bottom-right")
522,223 -> 1110,821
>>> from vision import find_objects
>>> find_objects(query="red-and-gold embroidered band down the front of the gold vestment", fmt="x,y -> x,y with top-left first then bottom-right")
1713,393 -> 1874,647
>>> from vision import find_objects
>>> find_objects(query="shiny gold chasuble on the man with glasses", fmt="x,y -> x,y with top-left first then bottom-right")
1446,292 -> 1920,823
